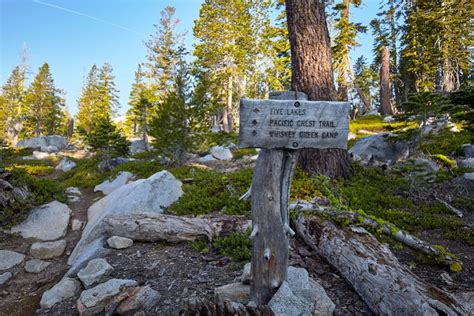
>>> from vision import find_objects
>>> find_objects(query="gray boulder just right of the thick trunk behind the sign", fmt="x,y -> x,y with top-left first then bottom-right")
349,133 -> 410,165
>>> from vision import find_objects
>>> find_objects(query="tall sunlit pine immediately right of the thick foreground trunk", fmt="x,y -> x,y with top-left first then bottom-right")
332,0 -> 366,100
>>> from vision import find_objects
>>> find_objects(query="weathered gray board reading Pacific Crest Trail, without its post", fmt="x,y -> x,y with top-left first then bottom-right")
239,99 -> 350,149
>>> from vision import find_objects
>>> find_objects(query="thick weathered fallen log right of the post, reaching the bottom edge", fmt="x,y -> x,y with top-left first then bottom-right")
294,216 -> 469,315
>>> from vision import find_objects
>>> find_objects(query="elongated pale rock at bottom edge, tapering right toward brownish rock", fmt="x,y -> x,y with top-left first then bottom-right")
77,279 -> 137,315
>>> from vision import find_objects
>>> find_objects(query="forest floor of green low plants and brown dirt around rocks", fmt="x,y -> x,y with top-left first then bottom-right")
0,113 -> 474,315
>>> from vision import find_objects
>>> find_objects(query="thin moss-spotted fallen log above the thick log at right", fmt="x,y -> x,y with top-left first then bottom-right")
290,201 -> 462,271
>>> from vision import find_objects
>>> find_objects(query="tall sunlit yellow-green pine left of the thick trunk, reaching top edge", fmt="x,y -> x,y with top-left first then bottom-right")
193,0 -> 256,131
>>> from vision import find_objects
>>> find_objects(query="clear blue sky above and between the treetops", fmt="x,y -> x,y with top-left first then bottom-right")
0,0 -> 379,114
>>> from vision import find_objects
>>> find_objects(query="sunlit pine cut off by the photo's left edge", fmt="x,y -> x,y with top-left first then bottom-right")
0,66 -> 28,144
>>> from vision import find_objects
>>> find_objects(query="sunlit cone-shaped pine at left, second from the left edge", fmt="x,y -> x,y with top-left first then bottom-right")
24,63 -> 65,136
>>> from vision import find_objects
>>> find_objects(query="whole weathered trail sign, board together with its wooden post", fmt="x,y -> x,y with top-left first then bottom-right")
239,91 -> 349,305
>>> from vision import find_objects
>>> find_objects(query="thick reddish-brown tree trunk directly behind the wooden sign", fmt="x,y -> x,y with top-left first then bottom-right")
286,0 -> 352,177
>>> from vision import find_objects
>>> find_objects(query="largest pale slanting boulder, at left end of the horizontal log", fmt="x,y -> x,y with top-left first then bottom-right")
68,170 -> 183,268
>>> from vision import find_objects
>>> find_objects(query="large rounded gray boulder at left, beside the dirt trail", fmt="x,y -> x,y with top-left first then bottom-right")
11,201 -> 72,240
